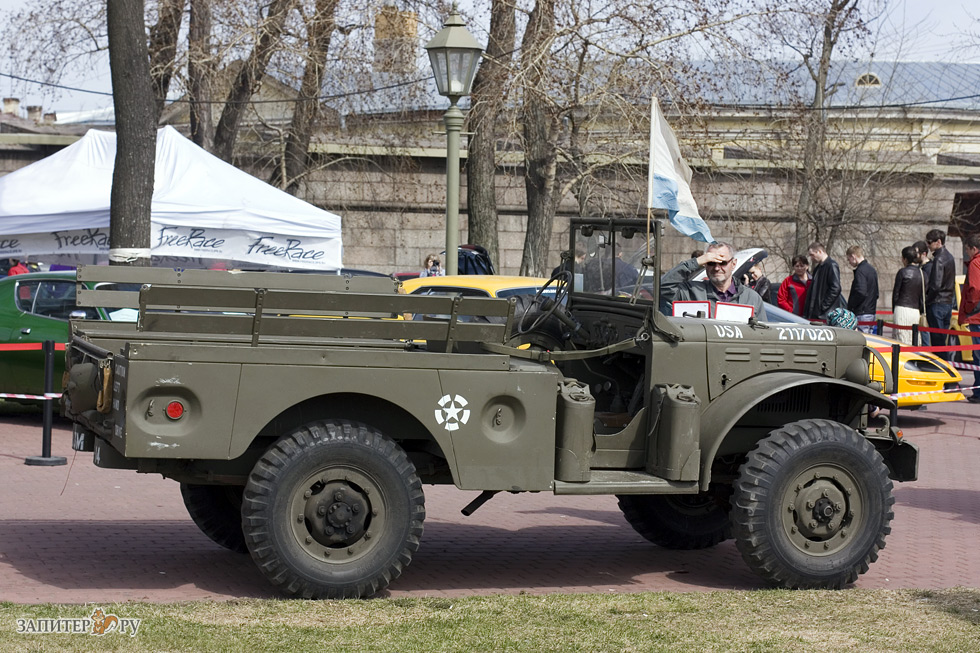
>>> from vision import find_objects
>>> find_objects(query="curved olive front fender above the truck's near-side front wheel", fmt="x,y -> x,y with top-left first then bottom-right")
701,372 -> 894,489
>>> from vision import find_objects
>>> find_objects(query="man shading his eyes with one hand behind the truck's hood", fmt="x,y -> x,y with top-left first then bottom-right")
660,242 -> 766,319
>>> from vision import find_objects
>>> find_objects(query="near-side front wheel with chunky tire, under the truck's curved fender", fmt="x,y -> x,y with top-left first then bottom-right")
732,420 -> 895,589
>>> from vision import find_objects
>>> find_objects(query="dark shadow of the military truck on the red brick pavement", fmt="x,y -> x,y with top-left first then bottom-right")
0,520 -> 763,598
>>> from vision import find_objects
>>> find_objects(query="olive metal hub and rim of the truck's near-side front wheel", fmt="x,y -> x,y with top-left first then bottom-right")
782,465 -> 863,555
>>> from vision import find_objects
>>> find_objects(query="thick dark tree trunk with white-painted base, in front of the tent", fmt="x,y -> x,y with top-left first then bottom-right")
106,0 -> 156,266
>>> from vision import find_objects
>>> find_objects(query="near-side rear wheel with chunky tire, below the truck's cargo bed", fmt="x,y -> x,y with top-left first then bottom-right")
242,420 -> 425,599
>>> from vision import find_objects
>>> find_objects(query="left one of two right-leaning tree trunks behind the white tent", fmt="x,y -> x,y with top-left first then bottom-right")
214,0 -> 296,163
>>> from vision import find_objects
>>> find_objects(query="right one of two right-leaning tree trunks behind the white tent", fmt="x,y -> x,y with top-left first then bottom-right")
271,0 -> 339,195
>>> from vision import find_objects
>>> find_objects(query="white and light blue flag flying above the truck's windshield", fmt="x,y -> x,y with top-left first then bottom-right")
647,97 -> 714,243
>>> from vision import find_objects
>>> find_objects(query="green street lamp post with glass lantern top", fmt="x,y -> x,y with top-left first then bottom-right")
425,6 -> 483,274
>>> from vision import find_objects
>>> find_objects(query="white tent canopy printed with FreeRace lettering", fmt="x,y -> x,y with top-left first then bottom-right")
0,127 -> 342,270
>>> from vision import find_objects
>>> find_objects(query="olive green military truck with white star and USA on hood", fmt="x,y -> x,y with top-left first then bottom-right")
63,219 -> 917,598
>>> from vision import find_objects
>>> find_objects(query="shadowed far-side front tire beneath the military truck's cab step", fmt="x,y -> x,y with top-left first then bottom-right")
616,493 -> 731,549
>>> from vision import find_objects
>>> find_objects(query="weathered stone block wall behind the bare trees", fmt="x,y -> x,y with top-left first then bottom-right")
296,159 -> 976,310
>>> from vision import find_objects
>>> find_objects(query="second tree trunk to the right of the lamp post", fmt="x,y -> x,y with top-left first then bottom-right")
520,0 -> 559,276
